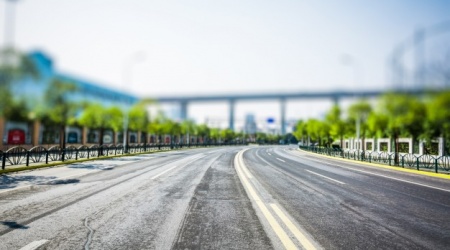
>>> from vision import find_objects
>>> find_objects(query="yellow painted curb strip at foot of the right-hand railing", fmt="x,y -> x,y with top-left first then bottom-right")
296,149 -> 450,180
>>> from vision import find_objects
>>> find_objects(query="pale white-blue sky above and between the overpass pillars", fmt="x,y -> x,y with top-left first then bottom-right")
0,0 -> 450,131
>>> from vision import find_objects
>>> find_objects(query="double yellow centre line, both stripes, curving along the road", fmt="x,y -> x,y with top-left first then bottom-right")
234,149 -> 316,249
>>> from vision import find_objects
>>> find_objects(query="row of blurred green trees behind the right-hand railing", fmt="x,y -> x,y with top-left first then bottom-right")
294,91 -> 450,155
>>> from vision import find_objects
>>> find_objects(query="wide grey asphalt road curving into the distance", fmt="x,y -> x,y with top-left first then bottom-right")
0,146 -> 450,249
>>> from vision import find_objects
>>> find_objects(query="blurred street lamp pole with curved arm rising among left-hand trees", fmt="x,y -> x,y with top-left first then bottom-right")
122,51 -> 146,153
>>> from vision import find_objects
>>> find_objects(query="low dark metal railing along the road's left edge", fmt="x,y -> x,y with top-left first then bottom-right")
0,143 -> 244,170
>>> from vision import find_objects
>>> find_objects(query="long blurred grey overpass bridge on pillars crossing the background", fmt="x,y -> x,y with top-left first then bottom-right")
144,89 -> 424,134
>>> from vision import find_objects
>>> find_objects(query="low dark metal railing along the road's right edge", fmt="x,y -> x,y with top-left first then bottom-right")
299,146 -> 450,173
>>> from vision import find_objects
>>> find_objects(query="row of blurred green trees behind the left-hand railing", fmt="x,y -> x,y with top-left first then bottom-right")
0,48 -> 277,147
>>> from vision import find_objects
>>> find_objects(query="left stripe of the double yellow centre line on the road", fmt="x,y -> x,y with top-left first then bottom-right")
235,149 -> 297,249
